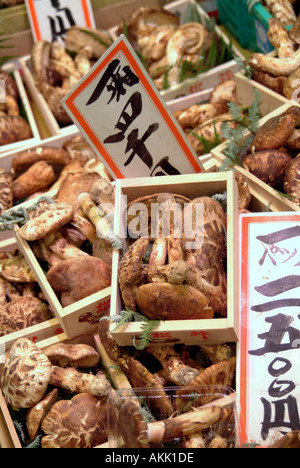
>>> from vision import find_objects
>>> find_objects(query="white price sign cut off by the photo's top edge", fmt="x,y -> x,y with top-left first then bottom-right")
26,0 -> 95,42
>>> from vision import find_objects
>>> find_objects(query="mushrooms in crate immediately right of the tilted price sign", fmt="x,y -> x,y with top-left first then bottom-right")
174,80 -> 238,156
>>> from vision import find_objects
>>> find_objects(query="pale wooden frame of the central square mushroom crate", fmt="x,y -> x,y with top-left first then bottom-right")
110,173 -> 239,346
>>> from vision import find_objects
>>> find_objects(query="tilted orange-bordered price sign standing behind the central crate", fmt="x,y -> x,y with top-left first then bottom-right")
62,35 -> 203,179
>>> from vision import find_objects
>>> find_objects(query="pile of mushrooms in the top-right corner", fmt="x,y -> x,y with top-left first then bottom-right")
248,15 -> 300,101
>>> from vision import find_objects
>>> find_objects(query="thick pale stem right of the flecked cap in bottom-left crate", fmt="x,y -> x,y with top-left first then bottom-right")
50,366 -> 112,397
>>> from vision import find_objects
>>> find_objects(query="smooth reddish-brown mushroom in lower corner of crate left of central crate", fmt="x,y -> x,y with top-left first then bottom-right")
46,256 -> 111,307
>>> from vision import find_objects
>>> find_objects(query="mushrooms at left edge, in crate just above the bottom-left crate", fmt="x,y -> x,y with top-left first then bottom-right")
0,250 -> 53,337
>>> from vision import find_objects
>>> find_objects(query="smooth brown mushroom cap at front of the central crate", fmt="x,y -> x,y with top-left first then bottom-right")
136,283 -> 214,320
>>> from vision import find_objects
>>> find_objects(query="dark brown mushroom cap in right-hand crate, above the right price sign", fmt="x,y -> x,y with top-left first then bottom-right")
243,150 -> 293,187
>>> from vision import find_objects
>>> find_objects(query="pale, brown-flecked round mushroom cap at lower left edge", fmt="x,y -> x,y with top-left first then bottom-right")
1,338 -> 52,408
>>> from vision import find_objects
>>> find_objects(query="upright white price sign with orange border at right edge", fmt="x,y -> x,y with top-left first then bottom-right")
237,213 -> 300,446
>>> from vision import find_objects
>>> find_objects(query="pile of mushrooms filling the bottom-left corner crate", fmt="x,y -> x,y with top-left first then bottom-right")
0,338 -> 113,448
